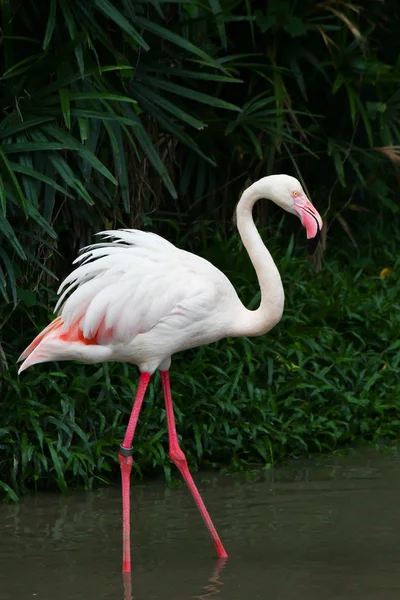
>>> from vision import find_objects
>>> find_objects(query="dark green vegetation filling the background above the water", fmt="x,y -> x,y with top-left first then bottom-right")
0,0 -> 400,500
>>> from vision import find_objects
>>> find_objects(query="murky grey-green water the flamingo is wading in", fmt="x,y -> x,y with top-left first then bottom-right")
0,449 -> 400,600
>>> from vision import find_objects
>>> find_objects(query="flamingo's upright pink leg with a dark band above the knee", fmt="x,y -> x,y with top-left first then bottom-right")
118,373 -> 150,573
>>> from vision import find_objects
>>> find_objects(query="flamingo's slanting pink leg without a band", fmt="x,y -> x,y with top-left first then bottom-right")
161,371 -> 228,558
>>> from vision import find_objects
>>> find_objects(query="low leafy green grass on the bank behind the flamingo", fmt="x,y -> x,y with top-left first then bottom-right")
0,218 -> 400,500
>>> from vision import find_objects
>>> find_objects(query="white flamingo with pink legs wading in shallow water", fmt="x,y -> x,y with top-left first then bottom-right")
19,175 -> 322,573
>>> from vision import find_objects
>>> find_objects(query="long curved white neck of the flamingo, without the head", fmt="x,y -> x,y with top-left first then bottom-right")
236,180 -> 285,336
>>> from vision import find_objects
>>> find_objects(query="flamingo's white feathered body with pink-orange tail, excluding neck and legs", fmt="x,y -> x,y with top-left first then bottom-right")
19,229 -> 246,374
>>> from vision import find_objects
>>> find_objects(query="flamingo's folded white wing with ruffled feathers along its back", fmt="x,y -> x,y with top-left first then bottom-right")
56,230 -> 230,344
